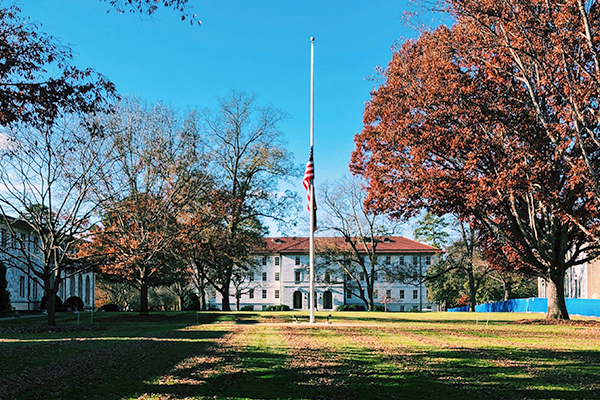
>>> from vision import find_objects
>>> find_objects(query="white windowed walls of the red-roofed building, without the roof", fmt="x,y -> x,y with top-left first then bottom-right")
210,253 -> 437,311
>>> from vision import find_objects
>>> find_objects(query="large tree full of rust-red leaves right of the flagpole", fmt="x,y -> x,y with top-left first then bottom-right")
352,7 -> 600,319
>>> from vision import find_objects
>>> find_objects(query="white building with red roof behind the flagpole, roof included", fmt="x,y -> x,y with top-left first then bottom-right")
210,236 -> 441,311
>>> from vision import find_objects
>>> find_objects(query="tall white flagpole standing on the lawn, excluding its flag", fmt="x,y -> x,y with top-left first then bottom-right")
308,37 -> 315,324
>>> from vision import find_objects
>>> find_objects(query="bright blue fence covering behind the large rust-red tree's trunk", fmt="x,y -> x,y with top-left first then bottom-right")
448,297 -> 600,317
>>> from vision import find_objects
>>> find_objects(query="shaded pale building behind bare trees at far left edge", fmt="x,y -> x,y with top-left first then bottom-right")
0,219 -> 95,311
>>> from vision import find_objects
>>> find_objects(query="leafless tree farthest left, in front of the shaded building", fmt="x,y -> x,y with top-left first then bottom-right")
0,117 -> 110,325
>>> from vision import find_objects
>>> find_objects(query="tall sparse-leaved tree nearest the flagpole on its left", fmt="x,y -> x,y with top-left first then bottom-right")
188,91 -> 298,311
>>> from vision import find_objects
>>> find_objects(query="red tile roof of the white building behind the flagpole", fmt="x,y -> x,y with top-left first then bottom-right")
264,236 -> 442,254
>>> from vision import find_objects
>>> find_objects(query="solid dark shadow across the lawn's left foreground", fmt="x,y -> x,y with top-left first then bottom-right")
0,330 -> 227,400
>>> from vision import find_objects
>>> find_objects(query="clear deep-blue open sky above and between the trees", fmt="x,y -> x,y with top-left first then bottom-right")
20,0 -> 440,233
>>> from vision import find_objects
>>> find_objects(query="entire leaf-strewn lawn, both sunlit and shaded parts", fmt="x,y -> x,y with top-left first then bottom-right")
0,312 -> 600,400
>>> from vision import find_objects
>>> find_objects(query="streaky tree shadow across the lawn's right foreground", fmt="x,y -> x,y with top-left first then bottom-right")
143,347 -> 600,400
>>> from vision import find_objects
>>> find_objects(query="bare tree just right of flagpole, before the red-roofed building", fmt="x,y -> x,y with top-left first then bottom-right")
317,178 -> 406,311
